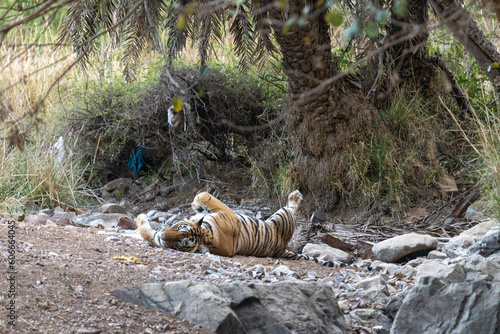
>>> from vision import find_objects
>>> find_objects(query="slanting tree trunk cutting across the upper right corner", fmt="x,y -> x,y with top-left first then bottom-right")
429,0 -> 500,93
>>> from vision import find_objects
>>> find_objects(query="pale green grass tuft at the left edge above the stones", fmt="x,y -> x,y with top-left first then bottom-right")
0,136 -> 91,212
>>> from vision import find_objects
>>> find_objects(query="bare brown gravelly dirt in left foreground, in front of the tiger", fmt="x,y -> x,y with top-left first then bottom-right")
0,220 -> 344,334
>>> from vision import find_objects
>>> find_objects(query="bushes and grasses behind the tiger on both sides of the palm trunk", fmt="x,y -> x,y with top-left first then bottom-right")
0,2 -> 500,222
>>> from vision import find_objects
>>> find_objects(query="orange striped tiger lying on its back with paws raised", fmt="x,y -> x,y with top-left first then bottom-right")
137,190 -> 345,267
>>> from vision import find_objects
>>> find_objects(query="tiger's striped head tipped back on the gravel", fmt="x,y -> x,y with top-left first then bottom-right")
162,217 -> 204,252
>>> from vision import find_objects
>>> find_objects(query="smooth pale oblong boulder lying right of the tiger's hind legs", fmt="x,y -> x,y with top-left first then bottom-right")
372,233 -> 437,262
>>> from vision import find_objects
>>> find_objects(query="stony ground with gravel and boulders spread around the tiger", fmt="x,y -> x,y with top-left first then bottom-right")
0,176 -> 500,333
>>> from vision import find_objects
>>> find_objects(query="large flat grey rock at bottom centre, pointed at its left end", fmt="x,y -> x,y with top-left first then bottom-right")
111,281 -> 351,334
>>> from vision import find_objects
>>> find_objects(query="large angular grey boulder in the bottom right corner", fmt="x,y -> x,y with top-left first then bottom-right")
391,278 -> 500,334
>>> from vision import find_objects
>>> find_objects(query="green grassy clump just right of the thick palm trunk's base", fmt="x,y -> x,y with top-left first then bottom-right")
346,90 -> 444,205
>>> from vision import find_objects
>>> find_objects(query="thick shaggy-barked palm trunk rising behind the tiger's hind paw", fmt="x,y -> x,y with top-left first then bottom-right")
269,0 -> 379,212
